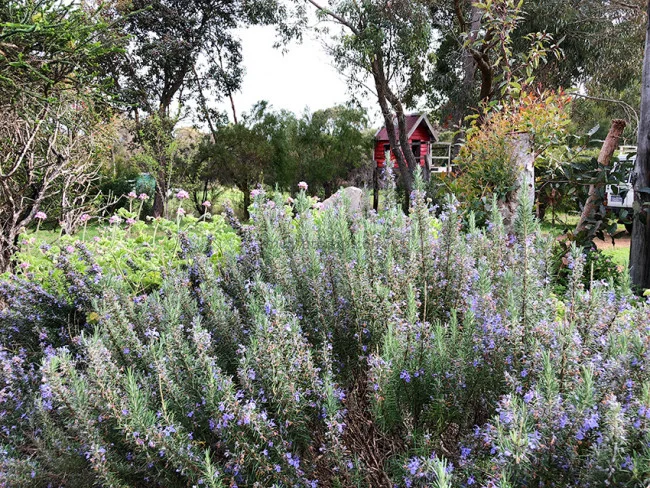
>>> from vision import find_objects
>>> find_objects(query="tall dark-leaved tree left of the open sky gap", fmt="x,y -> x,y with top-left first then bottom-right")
114,0 -> 289,215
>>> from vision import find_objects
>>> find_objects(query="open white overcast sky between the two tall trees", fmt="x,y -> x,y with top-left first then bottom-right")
219,26 -> 375,120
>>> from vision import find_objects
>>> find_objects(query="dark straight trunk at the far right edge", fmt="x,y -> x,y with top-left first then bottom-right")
630,0 -> 650,292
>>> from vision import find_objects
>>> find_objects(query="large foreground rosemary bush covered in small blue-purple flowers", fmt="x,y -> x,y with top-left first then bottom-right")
0,173 -> 650,488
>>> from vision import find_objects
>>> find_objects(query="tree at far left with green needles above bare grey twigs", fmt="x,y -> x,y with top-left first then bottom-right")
0,0 -> 119,270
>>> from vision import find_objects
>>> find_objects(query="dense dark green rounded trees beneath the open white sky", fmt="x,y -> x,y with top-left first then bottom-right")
186,102 -> 372,215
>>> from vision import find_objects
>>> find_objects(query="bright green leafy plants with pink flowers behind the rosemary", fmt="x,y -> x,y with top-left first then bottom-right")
15,208 -> 239,292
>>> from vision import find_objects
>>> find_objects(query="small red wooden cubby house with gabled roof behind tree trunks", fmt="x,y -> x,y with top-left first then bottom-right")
374,114 -> 438,169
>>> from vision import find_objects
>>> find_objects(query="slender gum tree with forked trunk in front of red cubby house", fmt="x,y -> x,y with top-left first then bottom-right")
296,0 -> 434,198
